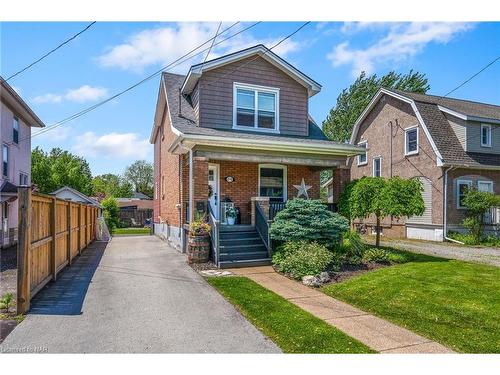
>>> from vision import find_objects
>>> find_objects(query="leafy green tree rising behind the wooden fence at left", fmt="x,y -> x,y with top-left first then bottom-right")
31,147 -> 92,195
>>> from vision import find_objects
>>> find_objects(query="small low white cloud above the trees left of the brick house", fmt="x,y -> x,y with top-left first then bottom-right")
72,132 -> 152,159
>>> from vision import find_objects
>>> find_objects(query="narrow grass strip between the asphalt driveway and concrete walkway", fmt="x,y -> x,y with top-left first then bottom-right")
207,277 -> 372,353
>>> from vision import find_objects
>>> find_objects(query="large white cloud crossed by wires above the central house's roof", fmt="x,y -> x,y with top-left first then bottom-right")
97,22 -> 301,72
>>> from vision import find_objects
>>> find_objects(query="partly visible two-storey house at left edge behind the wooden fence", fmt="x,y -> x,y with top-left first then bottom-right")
0,77 -> 45,247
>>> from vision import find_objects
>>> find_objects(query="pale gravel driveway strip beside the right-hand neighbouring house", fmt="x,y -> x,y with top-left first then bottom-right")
380,240 -> 500,267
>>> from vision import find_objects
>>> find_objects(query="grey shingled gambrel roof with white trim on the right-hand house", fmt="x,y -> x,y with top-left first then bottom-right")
350,88 -> 500,168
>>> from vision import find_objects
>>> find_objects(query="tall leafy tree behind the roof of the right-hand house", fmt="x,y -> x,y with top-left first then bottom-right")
323,70 -> 430,142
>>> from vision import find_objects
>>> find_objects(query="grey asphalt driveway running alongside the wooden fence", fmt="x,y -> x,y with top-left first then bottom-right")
0,236 -> 280,353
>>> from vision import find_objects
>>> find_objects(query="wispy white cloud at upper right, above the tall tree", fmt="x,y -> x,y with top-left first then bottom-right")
327,22 -> 473,76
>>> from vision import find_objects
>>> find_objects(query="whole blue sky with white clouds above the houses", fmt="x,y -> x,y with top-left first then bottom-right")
0,22 -> 500,175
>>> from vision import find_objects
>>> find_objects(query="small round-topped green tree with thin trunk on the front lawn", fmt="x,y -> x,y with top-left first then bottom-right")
349,177 -> 425,247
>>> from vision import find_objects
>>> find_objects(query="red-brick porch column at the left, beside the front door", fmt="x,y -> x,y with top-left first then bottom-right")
189,156 -> 208,221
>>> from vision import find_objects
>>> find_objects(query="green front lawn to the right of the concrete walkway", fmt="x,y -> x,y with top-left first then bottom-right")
322,250 -> 500,353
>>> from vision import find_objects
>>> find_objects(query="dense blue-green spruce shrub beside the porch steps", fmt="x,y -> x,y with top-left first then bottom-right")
269,198 -> 349,247
